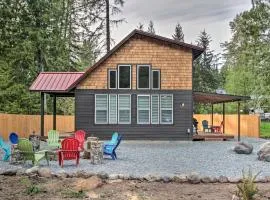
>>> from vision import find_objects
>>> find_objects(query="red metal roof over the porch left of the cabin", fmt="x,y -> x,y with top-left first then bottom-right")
30,72 -> 84,93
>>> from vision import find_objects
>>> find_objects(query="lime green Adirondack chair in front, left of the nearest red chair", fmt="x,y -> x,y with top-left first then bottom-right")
17,138 -> 49,165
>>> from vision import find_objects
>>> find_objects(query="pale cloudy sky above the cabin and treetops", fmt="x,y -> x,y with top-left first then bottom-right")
112,0 -> 251,53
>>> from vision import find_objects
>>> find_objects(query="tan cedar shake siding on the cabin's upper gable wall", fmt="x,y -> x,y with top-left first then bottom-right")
76,36 -> 192,90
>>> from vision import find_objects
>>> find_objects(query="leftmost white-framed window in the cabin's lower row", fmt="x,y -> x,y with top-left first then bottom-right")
95,94 -> 108,124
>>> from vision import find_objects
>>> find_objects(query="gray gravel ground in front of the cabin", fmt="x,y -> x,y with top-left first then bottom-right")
0,138 -> 270,177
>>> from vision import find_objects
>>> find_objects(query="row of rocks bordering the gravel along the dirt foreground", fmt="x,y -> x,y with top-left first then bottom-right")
0,166 -> 270,184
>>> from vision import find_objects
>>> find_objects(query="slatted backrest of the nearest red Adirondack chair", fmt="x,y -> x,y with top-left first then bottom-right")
61,138 -> 80,159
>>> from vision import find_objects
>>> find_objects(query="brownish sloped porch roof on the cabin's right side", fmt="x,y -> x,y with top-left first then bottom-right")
193,92 -> 250,104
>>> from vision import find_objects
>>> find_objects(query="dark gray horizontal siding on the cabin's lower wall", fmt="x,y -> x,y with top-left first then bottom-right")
75,90 -> 193,140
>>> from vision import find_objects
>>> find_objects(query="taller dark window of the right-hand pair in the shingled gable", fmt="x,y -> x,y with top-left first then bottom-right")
137,65 -> 150,89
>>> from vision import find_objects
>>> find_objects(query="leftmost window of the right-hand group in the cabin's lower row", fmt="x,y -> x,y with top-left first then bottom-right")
137,95 -> 150,124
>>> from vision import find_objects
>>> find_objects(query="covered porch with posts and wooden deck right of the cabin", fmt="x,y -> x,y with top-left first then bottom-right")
192,92 -> 250,141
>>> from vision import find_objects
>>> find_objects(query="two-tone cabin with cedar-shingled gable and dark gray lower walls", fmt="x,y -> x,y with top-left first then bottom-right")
30,30 -> 249,140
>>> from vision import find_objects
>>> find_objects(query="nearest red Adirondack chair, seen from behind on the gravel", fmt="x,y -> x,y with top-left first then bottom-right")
58,138 -> 80,167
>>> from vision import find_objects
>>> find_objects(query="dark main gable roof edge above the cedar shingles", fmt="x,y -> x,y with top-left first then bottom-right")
69,29 -> 204,90
